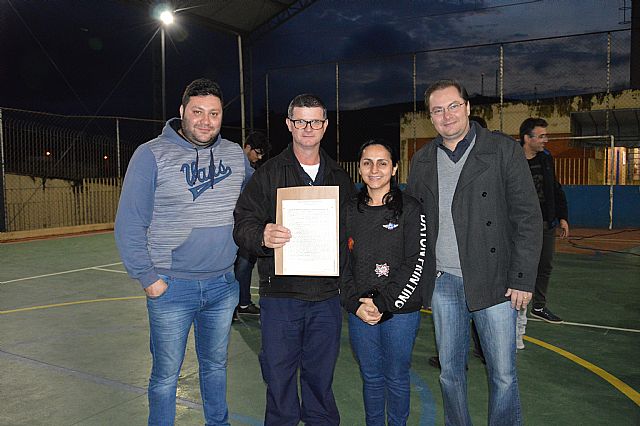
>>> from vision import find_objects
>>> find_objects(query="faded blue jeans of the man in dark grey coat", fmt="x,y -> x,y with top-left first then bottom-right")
431,272 -> 522,426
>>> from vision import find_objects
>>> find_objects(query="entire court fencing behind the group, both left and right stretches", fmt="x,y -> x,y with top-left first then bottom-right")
0,30 -> 640,232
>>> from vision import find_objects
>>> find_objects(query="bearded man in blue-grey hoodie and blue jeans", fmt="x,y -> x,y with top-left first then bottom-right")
115,79 -> 253,425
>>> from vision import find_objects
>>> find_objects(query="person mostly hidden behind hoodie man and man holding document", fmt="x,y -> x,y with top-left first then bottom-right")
233,132 -> 271,321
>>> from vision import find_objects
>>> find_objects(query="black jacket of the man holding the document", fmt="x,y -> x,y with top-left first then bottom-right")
233,145 -> 355,301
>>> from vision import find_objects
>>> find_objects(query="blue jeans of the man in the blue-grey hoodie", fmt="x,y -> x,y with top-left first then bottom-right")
147,272 -> 238,425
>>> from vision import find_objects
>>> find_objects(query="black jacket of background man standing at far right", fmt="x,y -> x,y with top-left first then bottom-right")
536,149 -> 569,228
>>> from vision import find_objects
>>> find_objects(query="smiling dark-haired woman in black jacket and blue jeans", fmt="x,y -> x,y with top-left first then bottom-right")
340,139 -> 426,425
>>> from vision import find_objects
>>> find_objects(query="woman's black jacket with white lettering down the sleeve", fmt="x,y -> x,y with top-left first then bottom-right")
340,194 -> 426,314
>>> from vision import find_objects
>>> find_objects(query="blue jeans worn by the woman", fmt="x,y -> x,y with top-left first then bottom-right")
349,311 -> 420,426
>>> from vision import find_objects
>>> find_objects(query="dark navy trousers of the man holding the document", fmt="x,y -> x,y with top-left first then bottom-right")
260,296 -> 342,426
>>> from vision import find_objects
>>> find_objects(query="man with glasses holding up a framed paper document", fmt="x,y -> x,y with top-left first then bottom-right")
233,94 -> 354,426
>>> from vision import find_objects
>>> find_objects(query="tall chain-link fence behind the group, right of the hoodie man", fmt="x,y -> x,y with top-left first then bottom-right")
265,30 -> 640,184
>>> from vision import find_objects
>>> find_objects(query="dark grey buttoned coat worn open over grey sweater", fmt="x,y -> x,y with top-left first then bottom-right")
407,126 -> 542,311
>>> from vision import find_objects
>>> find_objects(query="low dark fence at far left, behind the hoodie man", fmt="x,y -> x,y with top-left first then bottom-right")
0,108 -> 240,232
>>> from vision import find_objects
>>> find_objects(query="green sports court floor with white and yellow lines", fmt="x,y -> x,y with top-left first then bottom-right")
0,230 -> 640,425
